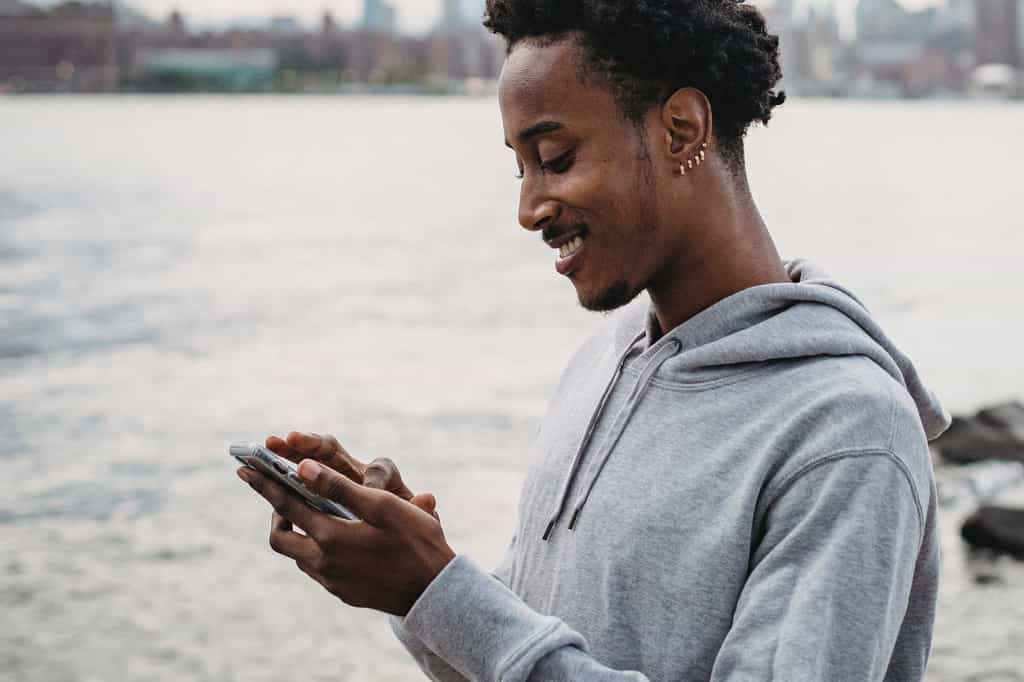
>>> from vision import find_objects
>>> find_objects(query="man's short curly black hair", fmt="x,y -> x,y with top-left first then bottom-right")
483,0 -> 785,169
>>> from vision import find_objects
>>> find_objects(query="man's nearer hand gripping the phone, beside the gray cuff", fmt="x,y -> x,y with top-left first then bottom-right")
239,458 -> 455,616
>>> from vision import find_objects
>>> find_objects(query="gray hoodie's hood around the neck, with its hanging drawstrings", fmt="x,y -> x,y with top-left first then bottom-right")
544,259 -> 951,540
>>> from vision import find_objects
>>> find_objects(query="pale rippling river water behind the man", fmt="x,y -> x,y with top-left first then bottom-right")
0,97 -> 1024,682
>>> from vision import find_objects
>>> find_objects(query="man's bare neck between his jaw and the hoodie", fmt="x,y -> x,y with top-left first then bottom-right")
647,196 -> 791,342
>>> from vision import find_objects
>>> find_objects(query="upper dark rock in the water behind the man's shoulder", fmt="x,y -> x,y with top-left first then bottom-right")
932,401 -> 1024,464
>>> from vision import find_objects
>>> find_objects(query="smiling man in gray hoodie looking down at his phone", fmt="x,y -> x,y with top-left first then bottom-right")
241,0 -> 949,681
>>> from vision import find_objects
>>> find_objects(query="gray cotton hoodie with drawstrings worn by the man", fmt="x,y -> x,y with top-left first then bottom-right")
391,260 -> 949,682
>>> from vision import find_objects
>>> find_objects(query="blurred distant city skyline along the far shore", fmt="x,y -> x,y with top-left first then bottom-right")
8,0 -> 1024,98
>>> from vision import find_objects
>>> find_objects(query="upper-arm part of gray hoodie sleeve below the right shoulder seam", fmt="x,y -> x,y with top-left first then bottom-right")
712,451 -> 932,680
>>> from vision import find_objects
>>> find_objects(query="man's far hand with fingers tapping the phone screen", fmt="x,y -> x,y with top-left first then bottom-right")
266,431 -> 439,520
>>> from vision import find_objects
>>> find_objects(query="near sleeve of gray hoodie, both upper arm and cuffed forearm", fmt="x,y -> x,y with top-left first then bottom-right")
389,453 -> 931,682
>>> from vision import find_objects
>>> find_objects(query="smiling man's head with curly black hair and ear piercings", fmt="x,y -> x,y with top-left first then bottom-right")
484,0 -> 784,310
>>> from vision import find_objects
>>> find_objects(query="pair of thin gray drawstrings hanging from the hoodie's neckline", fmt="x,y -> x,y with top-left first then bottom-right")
544,331 -> 683,540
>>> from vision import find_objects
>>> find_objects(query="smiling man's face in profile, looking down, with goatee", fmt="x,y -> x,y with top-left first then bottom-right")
499,38 -> 668,310
